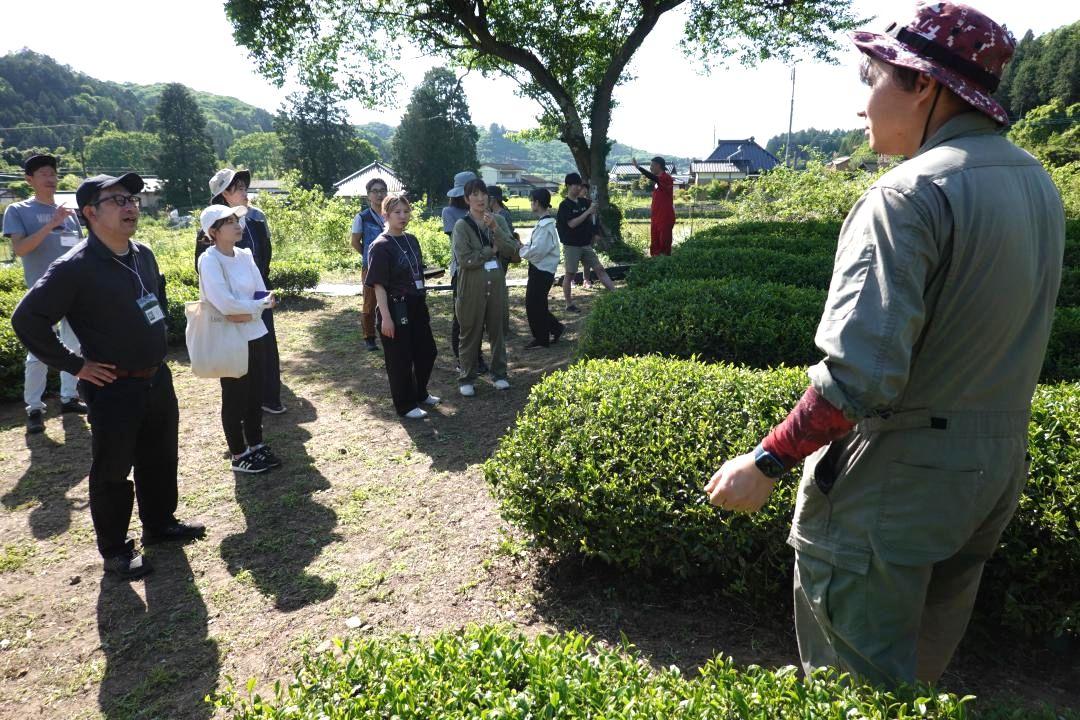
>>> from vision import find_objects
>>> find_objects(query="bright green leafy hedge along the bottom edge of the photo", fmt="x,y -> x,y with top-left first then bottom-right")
206,627 -> 1077,720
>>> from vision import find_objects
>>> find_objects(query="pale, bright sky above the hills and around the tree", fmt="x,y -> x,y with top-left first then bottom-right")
0,0 -> 1080,157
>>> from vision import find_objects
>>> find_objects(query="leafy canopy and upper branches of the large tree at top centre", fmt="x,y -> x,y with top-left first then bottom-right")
226,0 -> 861,208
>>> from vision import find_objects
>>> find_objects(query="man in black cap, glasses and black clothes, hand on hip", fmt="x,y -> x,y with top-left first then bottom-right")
11,173 -> 205,579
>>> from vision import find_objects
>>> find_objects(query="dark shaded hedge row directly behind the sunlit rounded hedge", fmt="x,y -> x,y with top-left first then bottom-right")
578,279 -> 825,367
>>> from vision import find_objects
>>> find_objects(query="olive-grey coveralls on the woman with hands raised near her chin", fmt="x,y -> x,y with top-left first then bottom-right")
450,215 -> 521,384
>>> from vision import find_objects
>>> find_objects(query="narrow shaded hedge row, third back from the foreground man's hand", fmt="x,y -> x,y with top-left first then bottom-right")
626,245 -> 833,290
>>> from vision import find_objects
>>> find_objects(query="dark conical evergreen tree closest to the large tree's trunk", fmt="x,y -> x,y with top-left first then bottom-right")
393,68 -> 477,201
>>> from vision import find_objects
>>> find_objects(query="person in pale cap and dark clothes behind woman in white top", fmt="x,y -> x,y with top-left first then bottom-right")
195,167 -> 285,415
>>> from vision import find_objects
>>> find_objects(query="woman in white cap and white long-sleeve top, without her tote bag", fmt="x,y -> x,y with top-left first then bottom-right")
199,205 -> 281,473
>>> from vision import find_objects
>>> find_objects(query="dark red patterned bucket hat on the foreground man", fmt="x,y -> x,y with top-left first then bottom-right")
851,2 -> 1016,125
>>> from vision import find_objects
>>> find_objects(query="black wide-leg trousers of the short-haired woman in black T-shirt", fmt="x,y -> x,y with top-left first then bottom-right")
375,297 -> 438,415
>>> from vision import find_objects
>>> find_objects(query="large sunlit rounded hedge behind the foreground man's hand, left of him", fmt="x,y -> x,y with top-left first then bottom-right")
484,356 -> 807,582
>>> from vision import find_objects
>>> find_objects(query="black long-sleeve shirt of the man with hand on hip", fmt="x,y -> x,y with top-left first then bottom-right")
11,231 -> 167,375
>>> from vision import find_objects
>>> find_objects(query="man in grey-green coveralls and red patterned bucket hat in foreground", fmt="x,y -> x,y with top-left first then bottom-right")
705,2 -> 1065,684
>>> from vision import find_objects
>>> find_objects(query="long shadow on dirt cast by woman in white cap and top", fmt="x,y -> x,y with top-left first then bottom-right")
221,386 -> 338,612
